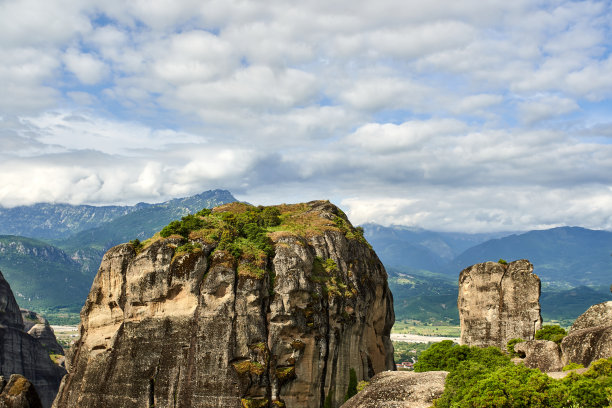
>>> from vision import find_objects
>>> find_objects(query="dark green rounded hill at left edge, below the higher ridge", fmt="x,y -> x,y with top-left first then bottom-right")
0,235 -> 92,312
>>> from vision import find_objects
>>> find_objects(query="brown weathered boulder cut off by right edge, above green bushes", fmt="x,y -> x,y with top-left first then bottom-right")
561,301 -> 612,367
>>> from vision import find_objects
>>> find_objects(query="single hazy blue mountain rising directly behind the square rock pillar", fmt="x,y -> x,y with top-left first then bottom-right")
444,227 -> 612,289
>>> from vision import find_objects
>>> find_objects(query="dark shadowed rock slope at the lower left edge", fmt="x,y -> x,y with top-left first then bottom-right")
0,273 -> 66,407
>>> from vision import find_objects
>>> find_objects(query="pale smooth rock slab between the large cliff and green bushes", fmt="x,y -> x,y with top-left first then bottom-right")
342,371 -> 448,408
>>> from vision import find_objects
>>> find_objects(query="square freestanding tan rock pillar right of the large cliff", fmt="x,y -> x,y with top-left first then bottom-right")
457,259 -> 542,350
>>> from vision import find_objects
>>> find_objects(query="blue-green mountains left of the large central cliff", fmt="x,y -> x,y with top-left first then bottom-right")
0,190 -> 236,316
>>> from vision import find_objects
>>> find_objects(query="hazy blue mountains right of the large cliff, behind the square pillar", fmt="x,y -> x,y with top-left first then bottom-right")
363,224 -> 612,324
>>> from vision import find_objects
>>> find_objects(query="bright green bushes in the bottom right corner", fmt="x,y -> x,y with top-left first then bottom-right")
415,341 -> 612,408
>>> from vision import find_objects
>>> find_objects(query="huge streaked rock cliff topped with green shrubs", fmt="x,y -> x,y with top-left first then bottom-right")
54,201 -> 394,408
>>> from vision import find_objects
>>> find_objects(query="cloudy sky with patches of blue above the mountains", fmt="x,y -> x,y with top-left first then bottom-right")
0,0 -> 612,232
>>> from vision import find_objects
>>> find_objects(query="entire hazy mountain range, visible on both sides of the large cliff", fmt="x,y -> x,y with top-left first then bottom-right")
0,190 -> 612,323
